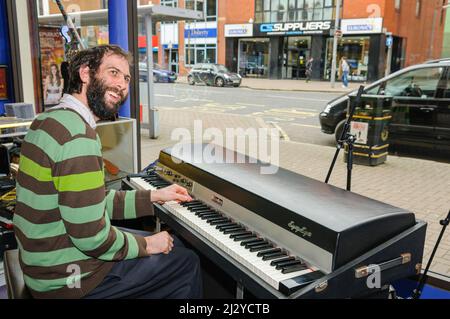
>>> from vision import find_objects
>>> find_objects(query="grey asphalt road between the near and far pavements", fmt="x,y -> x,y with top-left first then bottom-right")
140,83 -> 338,146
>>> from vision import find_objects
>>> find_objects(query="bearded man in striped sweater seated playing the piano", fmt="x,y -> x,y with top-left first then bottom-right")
14,45 -> 202,298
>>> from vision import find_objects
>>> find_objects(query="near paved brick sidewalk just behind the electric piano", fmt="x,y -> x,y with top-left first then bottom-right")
142,110 -> 450,277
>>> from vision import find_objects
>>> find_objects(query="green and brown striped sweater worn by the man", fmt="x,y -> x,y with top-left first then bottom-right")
14,109 -> 153,298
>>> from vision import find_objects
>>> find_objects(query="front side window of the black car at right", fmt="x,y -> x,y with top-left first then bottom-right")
384,67 -> 444,98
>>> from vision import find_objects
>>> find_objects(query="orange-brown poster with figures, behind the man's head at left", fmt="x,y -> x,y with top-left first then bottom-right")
39,27 -> 65,106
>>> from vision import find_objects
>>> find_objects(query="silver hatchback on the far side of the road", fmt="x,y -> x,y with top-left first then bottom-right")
187,63 -> 242,87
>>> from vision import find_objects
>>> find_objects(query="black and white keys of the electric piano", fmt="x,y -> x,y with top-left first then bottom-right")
130,174 -> 324,294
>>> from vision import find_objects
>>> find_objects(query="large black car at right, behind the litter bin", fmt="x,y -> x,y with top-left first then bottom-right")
319,59 -> 450,158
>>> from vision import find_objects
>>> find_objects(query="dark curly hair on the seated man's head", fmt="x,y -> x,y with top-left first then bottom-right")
67,44 -> 133,94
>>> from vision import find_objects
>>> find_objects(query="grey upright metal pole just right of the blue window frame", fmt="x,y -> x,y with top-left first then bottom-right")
145,14 -> 159,139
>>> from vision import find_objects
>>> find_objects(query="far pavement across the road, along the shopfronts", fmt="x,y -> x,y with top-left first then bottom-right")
176,76 -> 367,93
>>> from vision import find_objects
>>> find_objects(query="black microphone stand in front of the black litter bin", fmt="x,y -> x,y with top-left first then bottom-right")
325,85 -> 364,191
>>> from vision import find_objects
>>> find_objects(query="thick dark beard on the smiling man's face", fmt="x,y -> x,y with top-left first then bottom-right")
86,76 -> 128,120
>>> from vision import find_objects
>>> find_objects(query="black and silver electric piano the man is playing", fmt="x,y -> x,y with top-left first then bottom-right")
128,145 -> 426,298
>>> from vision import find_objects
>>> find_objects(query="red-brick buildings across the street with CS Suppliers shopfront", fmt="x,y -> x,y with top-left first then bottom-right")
44,0 -> 446,81
